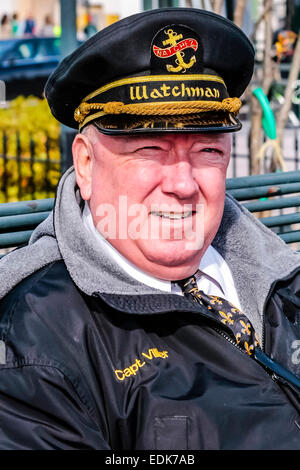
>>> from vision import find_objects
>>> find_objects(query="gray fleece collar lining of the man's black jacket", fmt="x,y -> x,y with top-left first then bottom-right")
0,167 -> 300,335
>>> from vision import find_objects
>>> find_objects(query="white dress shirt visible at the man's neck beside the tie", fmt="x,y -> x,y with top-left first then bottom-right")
82,203 -> 241,309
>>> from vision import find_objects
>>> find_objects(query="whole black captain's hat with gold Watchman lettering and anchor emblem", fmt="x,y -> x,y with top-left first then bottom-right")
45,8 -> 254,134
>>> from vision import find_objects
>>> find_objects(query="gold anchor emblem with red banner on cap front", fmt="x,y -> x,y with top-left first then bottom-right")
151,25 -> 202,73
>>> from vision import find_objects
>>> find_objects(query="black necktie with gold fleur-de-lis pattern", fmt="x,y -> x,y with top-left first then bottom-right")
178,276 -> 259,356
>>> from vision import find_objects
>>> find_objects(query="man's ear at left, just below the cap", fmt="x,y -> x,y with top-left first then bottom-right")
72,134 -> 93,201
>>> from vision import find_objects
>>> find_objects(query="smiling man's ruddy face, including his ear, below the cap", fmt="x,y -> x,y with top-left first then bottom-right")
73,126 -> 230,280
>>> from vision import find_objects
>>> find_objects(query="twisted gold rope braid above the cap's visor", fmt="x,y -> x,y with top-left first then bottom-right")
74,98 -> 242,124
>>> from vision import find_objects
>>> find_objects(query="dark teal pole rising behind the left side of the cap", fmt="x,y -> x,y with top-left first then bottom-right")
60,0 -> 78,173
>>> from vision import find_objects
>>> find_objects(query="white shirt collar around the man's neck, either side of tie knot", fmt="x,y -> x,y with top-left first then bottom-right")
82,202 -> 224,294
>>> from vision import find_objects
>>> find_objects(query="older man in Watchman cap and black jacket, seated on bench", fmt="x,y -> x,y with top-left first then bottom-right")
0,9 -> 300,450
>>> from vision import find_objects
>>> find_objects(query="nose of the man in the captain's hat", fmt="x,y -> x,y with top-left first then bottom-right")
161,161 -> 199,199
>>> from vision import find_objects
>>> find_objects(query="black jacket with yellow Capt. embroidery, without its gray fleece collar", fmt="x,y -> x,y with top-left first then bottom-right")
0,261 -> 300,450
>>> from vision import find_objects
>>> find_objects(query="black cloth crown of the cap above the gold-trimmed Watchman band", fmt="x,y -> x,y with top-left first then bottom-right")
45,8 -> 254,132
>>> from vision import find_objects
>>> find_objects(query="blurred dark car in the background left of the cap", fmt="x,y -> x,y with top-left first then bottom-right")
0,37 -> 79,100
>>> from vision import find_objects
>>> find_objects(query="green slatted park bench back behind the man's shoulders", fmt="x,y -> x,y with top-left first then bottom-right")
0,171 -> 300,256
